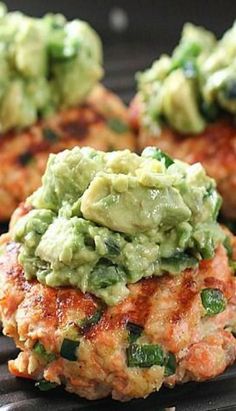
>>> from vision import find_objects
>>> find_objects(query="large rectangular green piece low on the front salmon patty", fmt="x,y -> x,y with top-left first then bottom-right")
126,344 -> 165,368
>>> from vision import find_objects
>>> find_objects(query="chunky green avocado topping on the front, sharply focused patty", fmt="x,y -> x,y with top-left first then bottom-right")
13,147 -> 225,304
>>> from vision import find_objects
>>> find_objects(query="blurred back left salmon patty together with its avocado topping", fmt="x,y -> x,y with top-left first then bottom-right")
0,5 -> 134,220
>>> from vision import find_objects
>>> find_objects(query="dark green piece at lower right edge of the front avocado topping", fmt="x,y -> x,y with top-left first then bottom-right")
160,252 -> 198,274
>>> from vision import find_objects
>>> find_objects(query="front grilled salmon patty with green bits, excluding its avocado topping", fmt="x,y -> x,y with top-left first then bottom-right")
0,206 -> 236,401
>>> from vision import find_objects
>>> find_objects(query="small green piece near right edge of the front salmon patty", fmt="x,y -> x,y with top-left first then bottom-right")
201,288 -> 226,316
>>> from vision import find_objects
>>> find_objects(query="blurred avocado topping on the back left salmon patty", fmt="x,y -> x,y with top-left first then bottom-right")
0,3 -> 103,132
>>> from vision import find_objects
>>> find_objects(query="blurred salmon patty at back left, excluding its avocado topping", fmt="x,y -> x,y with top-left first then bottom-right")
0,86 -> 135,221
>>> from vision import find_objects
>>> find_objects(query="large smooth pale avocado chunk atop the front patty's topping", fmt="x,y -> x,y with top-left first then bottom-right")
81,174 -> 191,234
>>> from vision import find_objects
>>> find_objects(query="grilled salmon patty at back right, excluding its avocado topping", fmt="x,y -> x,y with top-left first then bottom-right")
130,98 -> 236,219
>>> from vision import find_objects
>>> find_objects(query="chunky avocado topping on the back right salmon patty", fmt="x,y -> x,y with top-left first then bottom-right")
137,23 -> 236,135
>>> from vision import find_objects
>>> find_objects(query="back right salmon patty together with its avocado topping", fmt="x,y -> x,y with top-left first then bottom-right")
130,24 -> 236,218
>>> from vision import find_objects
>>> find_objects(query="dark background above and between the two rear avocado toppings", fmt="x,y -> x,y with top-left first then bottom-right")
5,0 -> 236,102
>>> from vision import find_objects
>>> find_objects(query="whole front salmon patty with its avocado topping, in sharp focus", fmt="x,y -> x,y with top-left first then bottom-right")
0,147 -> 236,401
